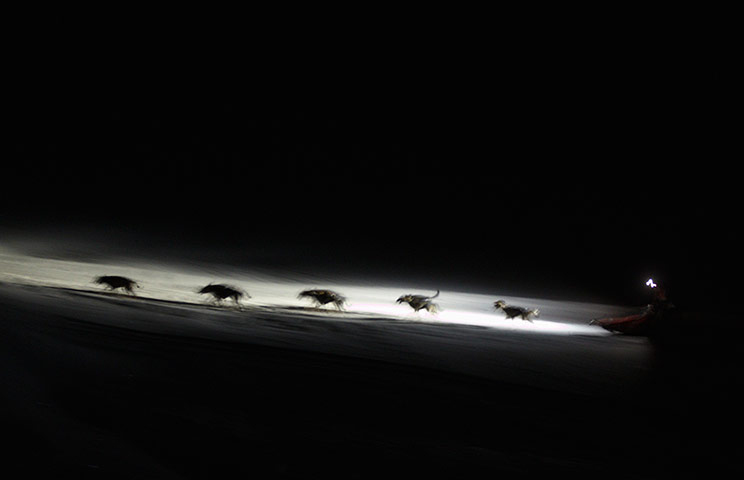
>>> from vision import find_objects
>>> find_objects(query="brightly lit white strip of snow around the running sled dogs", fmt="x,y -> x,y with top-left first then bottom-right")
0,246 -> 617,335
